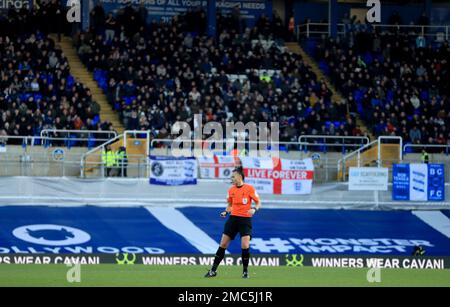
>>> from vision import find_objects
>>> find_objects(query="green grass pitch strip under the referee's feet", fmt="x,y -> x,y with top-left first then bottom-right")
0,264 -> 450,287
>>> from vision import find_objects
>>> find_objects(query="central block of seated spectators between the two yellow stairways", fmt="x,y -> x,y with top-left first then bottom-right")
76,5 -> 361,148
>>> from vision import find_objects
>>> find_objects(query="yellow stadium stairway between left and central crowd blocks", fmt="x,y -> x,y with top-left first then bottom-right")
50,35 -> 125,134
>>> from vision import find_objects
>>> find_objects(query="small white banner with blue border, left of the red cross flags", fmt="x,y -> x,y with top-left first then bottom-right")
150,156 -> 197,185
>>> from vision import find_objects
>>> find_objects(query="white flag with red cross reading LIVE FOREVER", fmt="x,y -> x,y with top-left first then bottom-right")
241,157 -> 314,194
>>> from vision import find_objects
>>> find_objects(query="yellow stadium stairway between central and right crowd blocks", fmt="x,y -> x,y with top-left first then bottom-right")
286,42 -> 375,140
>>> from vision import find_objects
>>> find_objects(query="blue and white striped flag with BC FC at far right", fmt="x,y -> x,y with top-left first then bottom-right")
392,164 -> 445,201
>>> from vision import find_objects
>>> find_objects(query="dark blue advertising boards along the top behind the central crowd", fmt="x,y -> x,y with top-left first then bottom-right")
99,0 -> 272,26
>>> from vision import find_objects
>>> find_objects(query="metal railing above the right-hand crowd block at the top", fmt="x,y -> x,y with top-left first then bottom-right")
296,22 -> 450,40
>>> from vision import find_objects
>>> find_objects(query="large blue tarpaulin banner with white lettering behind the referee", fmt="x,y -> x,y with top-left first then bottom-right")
0,204 -> 450,256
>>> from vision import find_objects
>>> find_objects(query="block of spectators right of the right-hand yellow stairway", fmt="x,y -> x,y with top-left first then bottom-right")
315,31 -> 450,149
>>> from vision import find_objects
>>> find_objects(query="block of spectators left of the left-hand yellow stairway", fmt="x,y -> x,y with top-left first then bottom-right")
0,8 -> 112,143
